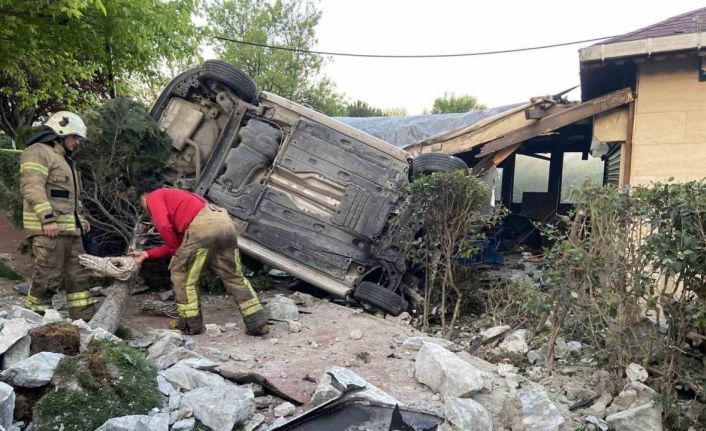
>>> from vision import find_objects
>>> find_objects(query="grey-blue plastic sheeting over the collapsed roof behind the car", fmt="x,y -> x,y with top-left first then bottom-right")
335,104 -> 520,148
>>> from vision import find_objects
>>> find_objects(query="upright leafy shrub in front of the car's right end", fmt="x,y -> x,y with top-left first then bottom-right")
403,170 -> 501,335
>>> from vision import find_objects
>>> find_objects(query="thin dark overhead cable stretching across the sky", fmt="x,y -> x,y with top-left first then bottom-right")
213,36 -> 614,58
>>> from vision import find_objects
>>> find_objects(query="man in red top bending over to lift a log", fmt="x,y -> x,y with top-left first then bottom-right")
131,180 -> 269,335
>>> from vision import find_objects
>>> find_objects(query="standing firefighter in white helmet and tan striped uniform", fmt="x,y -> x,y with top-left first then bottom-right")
20,111 -> 95,321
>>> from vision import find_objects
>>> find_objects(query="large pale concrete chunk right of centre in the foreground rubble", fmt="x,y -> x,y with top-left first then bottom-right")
415,343 -> 483,398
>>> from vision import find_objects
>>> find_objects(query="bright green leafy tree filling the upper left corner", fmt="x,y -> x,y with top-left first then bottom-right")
0,0 -> 200,138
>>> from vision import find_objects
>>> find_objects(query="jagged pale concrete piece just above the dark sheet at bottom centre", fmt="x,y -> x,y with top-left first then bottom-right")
309,366 -> 400,407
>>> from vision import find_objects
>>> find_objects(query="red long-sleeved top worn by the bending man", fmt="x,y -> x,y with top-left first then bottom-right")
147,189 -> 206,260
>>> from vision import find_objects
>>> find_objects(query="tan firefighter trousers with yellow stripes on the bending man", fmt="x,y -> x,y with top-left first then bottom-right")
170,204 -> 267,335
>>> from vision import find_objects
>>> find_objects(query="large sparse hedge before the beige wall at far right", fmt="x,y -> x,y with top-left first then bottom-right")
545,182 -> 706,426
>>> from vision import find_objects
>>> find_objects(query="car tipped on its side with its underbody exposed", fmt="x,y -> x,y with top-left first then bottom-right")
151,60 -> 466,315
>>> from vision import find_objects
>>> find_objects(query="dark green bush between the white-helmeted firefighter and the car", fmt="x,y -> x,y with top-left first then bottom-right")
76,98 -> 171,253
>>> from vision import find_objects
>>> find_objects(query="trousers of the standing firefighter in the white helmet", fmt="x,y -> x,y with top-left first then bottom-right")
26,235 -> 95,321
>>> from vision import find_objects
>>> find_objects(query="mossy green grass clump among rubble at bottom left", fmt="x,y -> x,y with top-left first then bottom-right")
34,341 -> 160,431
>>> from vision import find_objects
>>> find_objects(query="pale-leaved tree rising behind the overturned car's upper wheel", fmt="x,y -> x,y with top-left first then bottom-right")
207,0 -> 345,115
